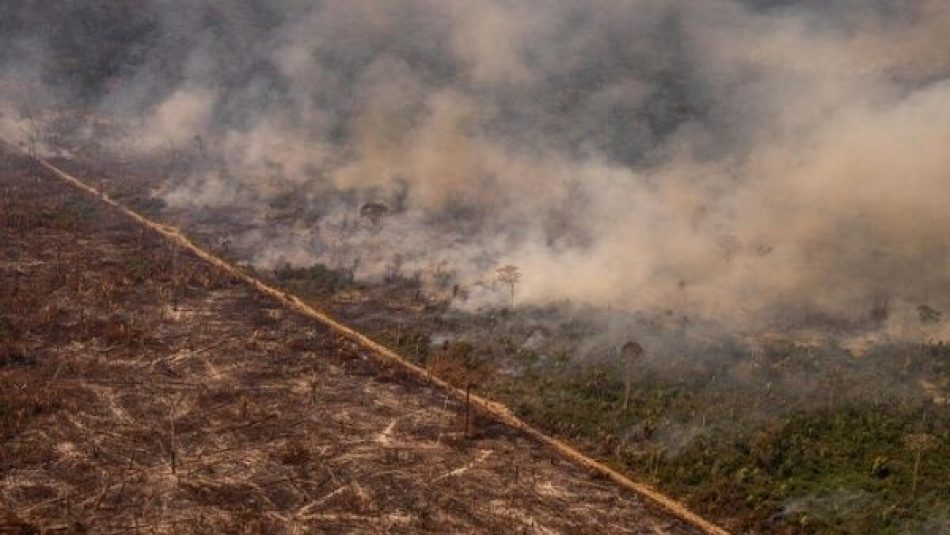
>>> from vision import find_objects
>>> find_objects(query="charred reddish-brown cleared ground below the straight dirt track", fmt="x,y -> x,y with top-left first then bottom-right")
0,149 -> 695,534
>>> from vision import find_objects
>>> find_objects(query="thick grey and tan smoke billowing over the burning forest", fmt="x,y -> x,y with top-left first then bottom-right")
0,0 -> 950,342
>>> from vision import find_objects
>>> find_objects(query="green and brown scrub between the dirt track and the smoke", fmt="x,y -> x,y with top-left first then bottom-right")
262,266 -> 950,533
